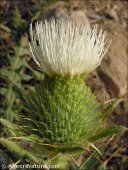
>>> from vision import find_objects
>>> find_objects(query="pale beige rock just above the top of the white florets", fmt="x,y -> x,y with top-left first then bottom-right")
71,10 -> 90,25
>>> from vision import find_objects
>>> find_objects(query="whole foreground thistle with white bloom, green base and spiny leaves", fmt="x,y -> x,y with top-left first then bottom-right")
1,20 -> 124,169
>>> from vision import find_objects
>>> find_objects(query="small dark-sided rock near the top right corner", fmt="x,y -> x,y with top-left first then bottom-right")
105,8 -> 119,21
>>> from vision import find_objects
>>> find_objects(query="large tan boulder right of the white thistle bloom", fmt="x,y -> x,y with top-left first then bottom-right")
98,23 -> 127,97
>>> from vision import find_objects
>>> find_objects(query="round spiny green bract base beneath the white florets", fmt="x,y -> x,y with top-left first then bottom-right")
24,76 -> 102,146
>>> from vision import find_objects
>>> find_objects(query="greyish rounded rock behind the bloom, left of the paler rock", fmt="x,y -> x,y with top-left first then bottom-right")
43,8 -> 70,20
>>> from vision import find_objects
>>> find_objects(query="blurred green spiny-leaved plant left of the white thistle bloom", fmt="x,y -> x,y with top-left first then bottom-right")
0,36 -> 40,122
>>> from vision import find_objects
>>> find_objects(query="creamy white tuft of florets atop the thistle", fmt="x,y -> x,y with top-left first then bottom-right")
29,20 -> 110,77
